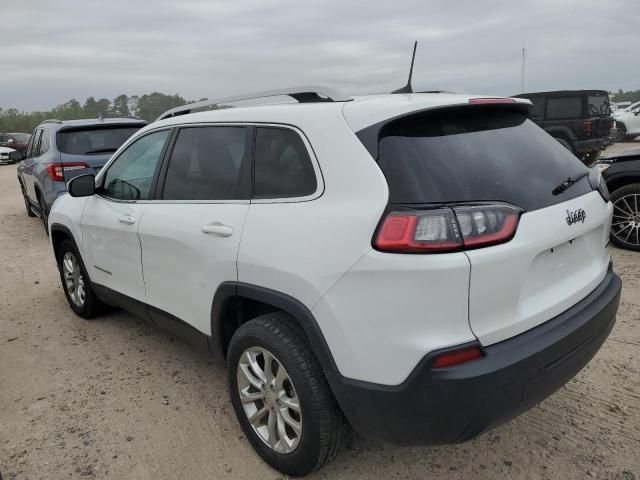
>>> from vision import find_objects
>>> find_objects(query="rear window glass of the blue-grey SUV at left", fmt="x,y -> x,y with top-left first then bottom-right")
56,126 -> 142,155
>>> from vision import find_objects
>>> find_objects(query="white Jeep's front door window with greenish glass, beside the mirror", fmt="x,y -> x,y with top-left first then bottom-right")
102,130 -> 171,200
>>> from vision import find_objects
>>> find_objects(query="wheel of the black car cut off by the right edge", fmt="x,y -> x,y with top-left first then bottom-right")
609,183 -> 640,252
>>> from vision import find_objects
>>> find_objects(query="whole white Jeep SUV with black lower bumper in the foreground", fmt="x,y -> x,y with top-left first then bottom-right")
49,88 -> 621,475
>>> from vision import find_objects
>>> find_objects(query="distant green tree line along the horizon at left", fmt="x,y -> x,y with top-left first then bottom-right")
0,92 -> 191,133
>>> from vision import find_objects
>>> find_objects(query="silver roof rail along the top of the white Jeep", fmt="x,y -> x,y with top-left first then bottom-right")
156,86 -> 353,122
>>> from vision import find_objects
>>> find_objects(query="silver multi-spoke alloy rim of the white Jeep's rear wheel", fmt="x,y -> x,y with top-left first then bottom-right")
237,347 -> 302,454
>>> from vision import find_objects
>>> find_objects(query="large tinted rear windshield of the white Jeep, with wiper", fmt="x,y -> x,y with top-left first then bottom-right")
378,108 -> 591,210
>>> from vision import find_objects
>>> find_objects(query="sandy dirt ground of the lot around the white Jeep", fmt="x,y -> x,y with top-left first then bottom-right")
0,142 -> 640,480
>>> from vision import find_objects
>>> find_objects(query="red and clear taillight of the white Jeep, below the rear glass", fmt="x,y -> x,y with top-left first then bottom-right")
373,205 -> 520,253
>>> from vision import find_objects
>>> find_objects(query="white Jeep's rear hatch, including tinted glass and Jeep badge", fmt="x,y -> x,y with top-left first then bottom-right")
358,105 -> 611,345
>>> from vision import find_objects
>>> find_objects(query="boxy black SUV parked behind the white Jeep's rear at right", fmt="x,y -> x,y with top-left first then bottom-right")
514,90 -> 613,164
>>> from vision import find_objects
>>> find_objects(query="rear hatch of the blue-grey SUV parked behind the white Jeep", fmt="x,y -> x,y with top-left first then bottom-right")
56,122 -> 146,180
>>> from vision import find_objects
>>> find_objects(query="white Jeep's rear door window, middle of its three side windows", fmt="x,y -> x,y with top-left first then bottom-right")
162,126 -> 251,200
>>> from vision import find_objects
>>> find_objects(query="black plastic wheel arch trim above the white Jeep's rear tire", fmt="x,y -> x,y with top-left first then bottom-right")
210,282 -> 338,377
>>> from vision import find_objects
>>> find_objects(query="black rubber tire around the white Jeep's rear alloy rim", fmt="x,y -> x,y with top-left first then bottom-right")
227,312 -> 347,476
